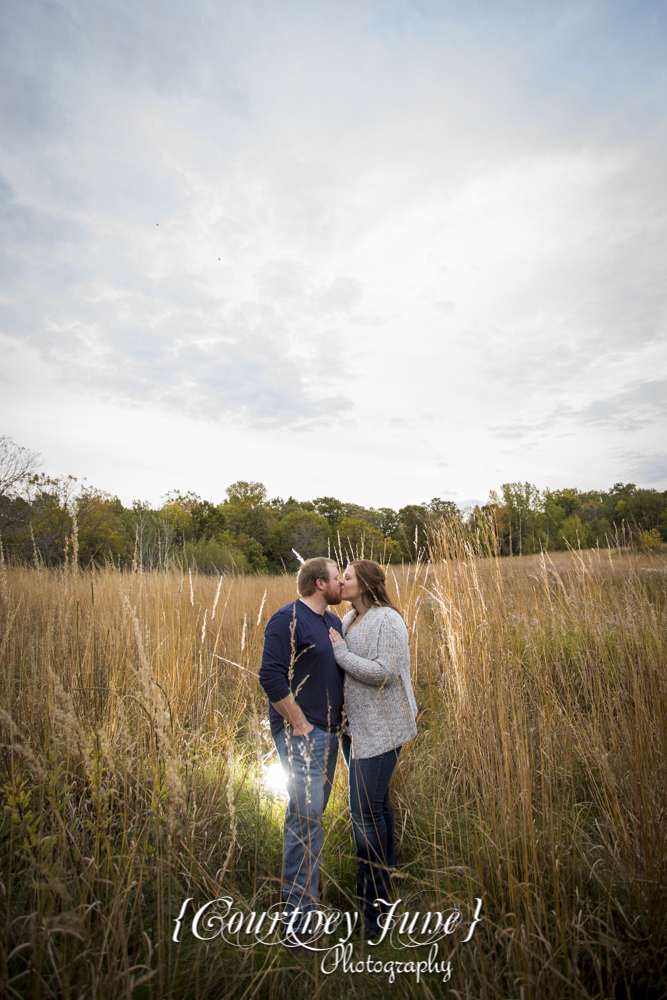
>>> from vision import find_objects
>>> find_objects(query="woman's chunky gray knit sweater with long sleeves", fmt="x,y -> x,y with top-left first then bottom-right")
333,608 -> 417,758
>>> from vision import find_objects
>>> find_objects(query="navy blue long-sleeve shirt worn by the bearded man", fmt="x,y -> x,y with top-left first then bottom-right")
259,600 -> 345,735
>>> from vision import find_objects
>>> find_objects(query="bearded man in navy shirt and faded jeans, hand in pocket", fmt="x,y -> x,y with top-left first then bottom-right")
259,558 -> 344,930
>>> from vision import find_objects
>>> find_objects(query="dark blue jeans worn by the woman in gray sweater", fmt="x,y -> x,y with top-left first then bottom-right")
341,736 -> 401,935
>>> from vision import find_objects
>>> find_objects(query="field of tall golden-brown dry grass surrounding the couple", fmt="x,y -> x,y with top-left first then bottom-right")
0,537 -> 667,1000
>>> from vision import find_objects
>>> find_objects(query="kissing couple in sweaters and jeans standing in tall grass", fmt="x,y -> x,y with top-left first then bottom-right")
259,557 -> 417,951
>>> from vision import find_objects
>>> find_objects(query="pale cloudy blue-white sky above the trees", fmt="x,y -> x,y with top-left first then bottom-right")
0,0 -> 667,508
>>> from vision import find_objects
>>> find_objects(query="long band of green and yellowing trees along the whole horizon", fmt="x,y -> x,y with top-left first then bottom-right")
0,437 -> 667,573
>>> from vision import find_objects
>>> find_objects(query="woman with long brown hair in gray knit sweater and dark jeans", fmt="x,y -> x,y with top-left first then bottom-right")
329,559 -> 417,937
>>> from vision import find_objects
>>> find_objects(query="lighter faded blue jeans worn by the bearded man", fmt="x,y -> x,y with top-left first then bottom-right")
273,726 -> 338,913
